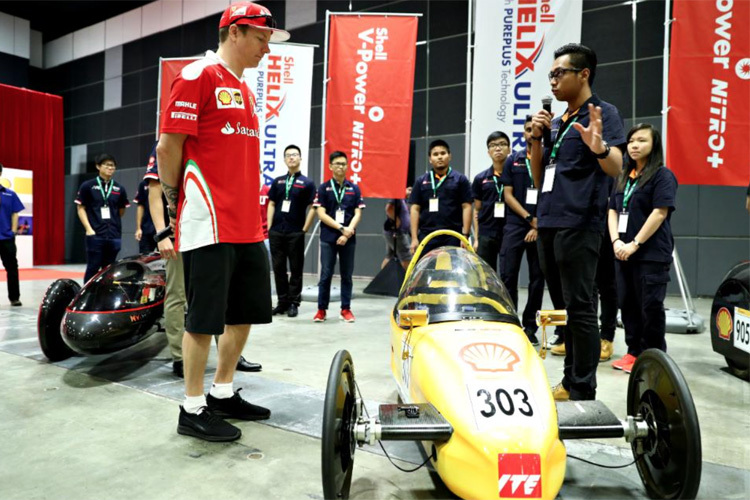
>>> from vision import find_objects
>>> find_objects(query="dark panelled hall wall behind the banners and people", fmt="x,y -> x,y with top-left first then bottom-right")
0,0 -> 750,296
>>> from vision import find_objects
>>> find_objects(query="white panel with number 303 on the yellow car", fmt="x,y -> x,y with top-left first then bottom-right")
467,381 -> 537,430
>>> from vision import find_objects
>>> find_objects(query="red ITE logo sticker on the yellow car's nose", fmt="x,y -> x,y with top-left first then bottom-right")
497,453 -> 542,498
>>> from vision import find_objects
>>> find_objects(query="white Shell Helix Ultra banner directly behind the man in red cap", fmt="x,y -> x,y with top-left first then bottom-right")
250,44 -> 314,184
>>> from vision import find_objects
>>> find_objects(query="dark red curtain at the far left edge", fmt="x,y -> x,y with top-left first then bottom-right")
0,85 -> 65,265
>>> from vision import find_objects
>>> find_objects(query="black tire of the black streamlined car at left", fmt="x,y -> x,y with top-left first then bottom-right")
36,279 -> 81,361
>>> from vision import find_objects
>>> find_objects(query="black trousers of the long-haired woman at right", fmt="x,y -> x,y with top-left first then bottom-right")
617,260 -> 670,357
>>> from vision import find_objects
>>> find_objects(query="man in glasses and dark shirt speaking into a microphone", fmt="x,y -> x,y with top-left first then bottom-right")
531,44 -> 625,401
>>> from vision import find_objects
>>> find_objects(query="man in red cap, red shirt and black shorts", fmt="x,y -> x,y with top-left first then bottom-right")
156,2 -> 289,441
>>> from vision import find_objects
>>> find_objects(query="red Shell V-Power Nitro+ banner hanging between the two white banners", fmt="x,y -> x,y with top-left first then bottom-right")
323,14 -> 418,198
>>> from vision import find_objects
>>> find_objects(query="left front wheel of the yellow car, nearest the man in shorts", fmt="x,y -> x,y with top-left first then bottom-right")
321,350 -> 357,500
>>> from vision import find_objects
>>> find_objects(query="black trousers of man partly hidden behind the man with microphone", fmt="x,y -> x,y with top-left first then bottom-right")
500,225 -> 544,331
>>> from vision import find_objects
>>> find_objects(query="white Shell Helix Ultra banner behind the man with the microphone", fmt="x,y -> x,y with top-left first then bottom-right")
467,0 -> 583,178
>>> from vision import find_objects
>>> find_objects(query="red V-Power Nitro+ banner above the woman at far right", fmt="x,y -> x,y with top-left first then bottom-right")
667,0 -> 750,186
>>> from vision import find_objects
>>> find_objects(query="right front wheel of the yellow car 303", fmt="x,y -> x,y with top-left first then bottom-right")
628,349 -> 702,499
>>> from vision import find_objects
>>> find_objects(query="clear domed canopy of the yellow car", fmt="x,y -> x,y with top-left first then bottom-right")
394,247 -> 518,323
